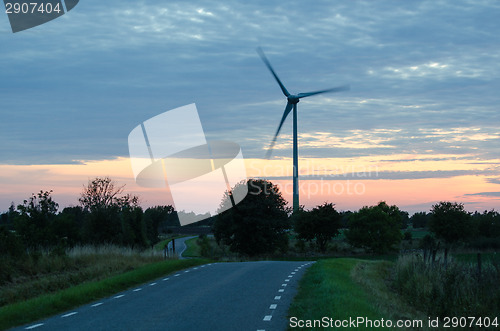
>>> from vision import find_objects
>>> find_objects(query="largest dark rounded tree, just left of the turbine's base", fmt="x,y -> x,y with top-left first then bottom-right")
213,179 -> 291,256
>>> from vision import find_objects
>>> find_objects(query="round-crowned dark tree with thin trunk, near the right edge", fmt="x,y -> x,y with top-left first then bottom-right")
429,201 -> 472,265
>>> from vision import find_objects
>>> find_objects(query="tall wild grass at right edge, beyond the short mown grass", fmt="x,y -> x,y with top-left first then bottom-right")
394,255 -> 500,317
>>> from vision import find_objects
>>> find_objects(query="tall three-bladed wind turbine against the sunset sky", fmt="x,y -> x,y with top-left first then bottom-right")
257,47 -> 350,212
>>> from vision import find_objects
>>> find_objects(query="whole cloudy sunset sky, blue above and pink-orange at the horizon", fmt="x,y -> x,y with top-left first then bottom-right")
0,0 -> 500,213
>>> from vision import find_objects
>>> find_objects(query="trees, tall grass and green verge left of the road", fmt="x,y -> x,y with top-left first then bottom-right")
0,177 -> 207,329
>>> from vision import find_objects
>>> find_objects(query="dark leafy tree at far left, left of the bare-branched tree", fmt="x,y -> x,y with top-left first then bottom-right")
14,191 -> 59,249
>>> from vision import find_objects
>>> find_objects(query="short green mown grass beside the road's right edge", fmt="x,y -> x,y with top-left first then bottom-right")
288,258 -> 427,330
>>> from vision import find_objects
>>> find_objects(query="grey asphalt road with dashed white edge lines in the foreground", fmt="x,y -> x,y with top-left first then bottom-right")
16,261 -> 312,331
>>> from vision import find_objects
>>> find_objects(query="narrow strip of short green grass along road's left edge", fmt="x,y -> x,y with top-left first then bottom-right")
0,259 -> 209,330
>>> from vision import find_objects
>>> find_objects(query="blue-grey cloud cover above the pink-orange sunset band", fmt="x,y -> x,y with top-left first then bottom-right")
0,0 -> 500,169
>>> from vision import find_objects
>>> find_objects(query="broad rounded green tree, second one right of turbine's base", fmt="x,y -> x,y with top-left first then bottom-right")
344,202 -> 402,253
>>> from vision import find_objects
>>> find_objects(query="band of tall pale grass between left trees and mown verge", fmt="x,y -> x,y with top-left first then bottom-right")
0,245 -> 163,307
